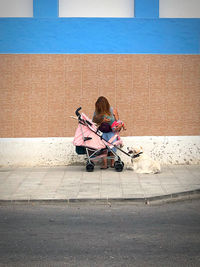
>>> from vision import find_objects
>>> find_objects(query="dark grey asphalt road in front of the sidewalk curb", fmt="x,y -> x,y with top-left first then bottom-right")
0,200 -> 200,267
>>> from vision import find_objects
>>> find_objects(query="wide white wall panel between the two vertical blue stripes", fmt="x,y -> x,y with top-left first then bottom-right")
59,0 -> 134,17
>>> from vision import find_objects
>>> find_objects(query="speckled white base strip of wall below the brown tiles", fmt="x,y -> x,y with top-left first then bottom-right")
0,136 -> 200,166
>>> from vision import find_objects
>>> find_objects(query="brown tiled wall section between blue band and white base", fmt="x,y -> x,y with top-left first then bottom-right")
0,55 -> 200,137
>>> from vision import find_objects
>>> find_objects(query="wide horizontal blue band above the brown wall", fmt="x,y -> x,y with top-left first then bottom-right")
0,18 -> 200,54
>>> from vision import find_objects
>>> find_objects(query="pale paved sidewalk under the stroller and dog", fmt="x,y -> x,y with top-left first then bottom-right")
0,165 -> 200,202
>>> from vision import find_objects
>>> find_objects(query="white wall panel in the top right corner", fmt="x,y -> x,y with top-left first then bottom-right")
159,0 -> 200,18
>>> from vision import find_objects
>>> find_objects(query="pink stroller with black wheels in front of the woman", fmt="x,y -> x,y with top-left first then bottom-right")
73,107 -> 134,172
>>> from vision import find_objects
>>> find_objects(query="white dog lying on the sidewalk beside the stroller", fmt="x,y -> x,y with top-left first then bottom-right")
127,147 -> 161,173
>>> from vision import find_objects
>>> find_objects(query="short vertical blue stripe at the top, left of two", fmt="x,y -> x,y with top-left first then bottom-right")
33,0 -> 59,18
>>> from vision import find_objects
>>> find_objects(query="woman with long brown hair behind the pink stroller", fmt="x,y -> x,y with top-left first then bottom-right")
93,96 -> 125,169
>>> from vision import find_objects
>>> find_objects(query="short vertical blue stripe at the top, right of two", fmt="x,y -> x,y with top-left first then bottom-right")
134,0 -> 159,18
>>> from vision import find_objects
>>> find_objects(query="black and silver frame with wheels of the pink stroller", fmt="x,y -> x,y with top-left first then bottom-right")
75,107 -> 135,172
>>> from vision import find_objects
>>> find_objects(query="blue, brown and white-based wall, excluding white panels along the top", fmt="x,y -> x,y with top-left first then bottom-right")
0,0 -> 200,166
